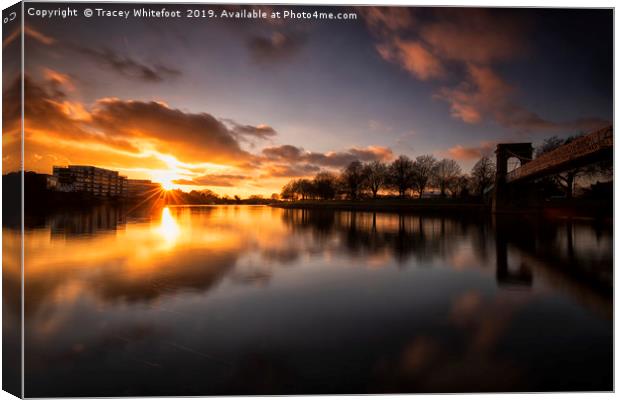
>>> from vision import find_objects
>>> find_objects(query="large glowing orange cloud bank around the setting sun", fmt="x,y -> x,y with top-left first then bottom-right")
20,72 -> 393,187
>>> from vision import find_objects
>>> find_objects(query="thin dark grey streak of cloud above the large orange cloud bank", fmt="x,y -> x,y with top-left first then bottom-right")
72,45 -> 181,83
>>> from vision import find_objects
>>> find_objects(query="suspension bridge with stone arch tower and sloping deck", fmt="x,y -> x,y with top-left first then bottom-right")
493,126 -> 614,211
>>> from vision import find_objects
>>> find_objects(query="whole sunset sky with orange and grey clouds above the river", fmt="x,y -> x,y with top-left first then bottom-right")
3,4 -> 613,196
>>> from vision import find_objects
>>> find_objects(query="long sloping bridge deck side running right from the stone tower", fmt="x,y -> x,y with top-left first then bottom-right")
506,126 -> 614,182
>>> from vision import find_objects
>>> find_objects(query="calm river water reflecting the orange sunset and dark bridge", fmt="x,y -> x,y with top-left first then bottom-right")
4,206 -> 613,397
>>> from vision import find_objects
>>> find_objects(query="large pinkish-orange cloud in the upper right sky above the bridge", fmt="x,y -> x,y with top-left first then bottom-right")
361,8 -> 609,133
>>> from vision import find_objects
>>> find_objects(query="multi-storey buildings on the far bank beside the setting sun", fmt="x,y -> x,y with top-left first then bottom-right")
47,165 -> 161,198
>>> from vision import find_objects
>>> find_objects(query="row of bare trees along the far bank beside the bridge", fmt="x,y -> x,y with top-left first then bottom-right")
280,154 -> 495,200
